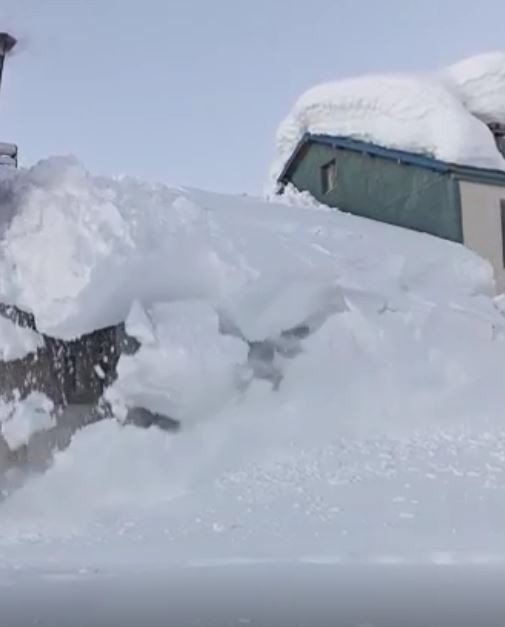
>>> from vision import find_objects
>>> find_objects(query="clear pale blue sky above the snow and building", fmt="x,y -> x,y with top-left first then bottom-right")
0,0 -> 505,193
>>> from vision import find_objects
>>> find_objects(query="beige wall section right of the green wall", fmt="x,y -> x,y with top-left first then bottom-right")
460,181 -> 505,291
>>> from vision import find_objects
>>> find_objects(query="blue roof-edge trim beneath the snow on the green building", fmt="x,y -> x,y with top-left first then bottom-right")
277,133 -> 505,187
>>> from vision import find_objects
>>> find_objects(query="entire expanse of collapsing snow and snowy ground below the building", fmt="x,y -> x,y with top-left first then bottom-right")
0,161 -> 505,625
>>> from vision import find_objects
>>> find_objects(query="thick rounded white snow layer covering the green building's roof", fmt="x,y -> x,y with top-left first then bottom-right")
270,53 -> 505,190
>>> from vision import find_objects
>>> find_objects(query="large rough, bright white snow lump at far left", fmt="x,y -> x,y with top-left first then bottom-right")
0,158 -> 132,336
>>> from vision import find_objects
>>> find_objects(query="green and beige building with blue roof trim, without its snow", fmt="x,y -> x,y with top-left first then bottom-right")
278,131 -> 505,289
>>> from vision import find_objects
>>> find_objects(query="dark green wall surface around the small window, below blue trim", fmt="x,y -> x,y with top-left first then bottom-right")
289,144 -> 463,242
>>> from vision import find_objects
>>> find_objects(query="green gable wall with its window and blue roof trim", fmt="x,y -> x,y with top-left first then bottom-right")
279,135 -> 505,242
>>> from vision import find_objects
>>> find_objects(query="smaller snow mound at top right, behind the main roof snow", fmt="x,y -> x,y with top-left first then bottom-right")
442,52 -> 505,124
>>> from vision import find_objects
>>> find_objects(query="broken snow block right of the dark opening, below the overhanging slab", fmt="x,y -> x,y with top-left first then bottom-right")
107,301 -> 247,422
